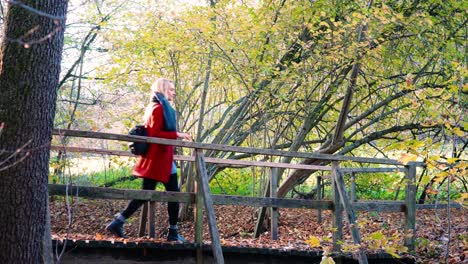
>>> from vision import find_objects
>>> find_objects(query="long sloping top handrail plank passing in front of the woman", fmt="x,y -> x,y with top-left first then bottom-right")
53,129 -> 402,165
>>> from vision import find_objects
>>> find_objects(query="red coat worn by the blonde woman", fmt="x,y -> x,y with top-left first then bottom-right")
133,103 -> 177,183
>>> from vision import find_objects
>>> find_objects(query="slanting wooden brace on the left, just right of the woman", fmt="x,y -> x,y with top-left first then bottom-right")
196,149 -> 224,264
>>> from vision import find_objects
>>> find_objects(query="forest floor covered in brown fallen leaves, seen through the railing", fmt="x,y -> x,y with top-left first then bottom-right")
50,197 -> 468,263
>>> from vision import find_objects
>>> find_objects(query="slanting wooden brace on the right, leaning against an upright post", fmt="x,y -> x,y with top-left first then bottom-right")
332,162 -> 368,264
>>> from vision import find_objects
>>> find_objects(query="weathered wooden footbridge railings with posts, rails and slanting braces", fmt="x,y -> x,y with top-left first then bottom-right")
49,129 -> 456,263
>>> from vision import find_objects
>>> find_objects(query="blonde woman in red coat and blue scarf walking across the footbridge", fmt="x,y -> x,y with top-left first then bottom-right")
106,79 -> 192,242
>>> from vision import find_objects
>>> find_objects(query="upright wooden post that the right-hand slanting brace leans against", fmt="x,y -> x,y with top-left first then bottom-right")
332,161 -> 343,252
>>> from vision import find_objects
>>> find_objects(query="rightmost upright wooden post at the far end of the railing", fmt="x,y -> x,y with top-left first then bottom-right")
405,162 -> 416,251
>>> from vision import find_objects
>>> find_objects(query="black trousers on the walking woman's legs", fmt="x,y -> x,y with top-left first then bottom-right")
122,173 -> 180,225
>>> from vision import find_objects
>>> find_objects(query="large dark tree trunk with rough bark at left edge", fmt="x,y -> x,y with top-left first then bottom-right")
0,0 -> 68,263
